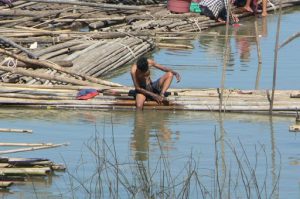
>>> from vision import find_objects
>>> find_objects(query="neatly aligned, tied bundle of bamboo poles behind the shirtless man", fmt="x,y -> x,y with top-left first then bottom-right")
70,37 -> 154,77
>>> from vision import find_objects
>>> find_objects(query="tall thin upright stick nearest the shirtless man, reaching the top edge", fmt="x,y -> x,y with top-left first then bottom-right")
219,0 -> 231,112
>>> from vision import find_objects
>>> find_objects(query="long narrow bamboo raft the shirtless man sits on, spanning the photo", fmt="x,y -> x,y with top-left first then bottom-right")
0,84 -> 300,114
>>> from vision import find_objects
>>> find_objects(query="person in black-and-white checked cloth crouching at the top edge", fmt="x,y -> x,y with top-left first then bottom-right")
199,0 -> 239,23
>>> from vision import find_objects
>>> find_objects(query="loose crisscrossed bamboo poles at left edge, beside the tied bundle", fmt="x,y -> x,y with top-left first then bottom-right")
0,37 -> 130,86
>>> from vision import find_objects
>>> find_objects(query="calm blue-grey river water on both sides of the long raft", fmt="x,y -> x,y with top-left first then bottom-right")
0,7 -> 300,198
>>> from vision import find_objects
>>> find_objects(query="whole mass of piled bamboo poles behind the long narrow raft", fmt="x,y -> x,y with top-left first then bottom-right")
0,0 -> 300,85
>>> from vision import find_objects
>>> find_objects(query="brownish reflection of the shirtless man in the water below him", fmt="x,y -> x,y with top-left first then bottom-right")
131,111 -> 178,161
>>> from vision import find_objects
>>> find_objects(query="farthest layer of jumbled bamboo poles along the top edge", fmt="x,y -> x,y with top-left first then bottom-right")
0,0 -> 299,32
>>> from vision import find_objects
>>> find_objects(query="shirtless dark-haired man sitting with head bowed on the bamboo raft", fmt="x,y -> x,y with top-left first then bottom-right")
130,57 -> 180,109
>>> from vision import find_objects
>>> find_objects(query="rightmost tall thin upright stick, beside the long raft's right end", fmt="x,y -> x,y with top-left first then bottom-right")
269,0 -> 282,114
